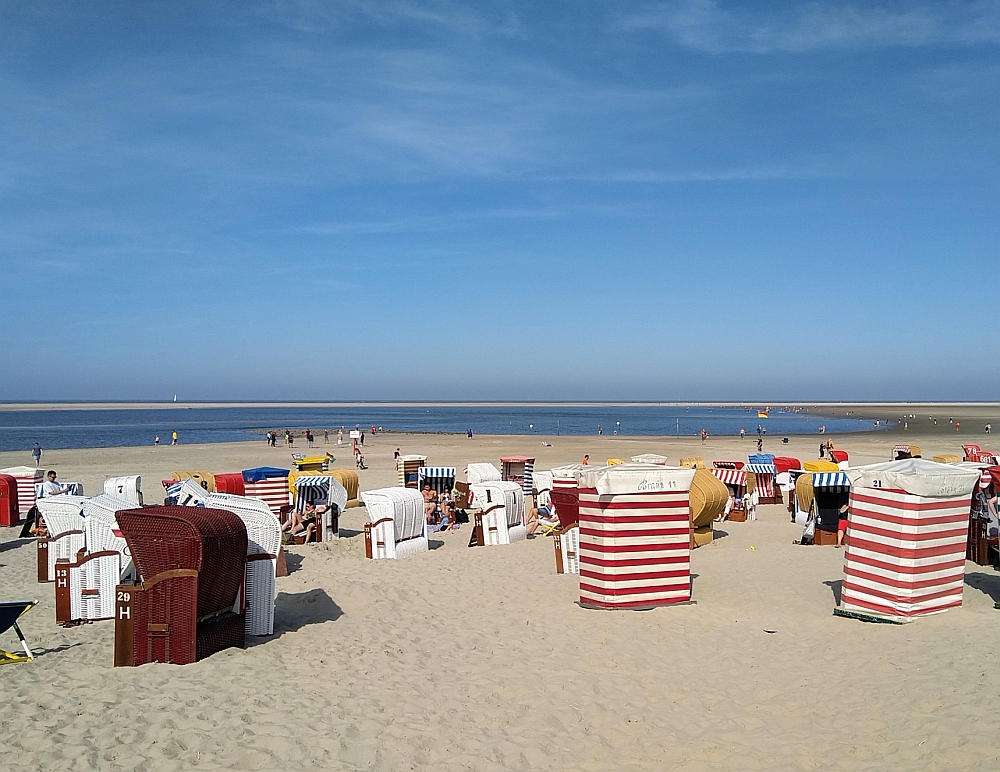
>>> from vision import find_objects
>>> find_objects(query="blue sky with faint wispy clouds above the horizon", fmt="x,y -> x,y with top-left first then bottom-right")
0,0 -> 1000,402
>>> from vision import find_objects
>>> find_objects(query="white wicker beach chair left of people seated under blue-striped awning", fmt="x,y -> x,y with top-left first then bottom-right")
361,488 -> 429,560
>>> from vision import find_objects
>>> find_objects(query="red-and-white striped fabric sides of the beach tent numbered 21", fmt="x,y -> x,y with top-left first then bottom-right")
840,487 -> 972,617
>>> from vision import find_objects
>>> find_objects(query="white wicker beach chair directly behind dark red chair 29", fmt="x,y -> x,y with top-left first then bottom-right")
205,493 -> 281,635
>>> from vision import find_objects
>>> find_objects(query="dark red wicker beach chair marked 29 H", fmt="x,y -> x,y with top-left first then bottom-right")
115,506 -> 247,667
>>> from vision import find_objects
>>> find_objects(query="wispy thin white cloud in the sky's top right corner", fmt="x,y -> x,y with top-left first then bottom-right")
614,0 -> 1000,54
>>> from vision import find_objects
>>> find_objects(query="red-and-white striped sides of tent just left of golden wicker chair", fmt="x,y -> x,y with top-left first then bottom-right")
579,488 -> 691,609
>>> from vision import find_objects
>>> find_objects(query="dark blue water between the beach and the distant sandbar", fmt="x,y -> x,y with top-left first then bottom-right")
0,403 -> 889,450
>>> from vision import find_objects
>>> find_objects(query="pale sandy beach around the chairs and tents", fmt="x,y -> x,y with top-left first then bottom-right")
0,426 -> 1000,770
